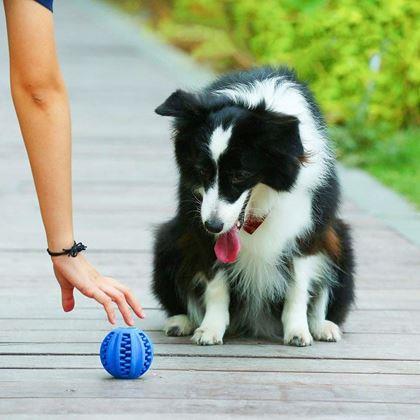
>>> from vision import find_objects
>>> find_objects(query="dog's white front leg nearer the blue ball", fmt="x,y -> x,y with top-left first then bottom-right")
192,270 -> 230,345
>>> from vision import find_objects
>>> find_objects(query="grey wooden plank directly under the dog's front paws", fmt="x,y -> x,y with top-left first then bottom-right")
0,333 -> 420,361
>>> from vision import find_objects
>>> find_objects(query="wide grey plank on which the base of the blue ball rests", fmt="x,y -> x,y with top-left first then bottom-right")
0,370 -> 420,404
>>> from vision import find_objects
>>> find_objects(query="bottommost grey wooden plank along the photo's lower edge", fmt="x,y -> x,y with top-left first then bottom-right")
0,396 -> 420,420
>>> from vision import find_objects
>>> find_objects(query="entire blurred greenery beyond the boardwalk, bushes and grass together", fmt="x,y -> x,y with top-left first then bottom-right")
104,0 -> 420,207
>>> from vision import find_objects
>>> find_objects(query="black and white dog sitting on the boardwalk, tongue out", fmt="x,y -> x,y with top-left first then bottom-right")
153,68 -> 354,346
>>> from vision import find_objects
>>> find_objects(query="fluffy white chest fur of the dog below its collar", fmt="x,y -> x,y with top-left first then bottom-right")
230,185 -> 312,310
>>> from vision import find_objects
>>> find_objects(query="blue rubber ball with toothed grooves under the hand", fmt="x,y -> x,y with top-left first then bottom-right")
100,327 -> 153,379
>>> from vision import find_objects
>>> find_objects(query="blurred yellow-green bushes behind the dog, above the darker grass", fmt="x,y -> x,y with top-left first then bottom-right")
154,0 -> 420,132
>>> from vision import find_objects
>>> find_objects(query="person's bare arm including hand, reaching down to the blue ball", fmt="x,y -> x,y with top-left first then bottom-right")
4,0 -> 143,325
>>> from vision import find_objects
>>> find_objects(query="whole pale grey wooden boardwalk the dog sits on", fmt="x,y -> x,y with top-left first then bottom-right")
0,0 -> 420,418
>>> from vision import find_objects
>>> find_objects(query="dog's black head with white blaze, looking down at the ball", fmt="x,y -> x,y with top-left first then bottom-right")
156,90 -> 304,260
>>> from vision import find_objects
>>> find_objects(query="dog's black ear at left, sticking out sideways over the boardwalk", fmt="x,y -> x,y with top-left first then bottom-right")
155,89 -> 203,118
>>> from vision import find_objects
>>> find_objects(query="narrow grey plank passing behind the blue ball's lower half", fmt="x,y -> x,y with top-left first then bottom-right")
0,355 -> 420,377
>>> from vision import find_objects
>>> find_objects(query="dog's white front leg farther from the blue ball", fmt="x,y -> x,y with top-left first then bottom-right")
281,257 -> 315,347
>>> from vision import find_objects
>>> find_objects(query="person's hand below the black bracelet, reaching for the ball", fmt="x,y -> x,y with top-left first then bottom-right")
51,254 -> 144,326
